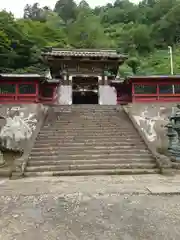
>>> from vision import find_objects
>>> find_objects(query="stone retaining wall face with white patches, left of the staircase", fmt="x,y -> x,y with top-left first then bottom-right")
0,104 -> 46,152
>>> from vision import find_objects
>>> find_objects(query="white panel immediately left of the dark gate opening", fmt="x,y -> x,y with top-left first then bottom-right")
58,85 -> 72,105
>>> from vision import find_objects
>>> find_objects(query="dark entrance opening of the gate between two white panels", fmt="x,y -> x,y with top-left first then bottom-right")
72,77 -> 99,104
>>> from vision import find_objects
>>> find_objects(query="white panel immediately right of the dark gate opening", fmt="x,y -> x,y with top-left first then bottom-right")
99,85 -> 117,105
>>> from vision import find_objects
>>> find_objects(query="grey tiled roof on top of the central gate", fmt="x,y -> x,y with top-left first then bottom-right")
42,48 -> 127,59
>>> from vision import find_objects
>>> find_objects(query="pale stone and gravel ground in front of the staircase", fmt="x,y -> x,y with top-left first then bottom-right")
0,175 -> 180,240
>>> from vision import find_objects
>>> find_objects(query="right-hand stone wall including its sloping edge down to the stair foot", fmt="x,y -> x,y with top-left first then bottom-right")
124,103 -> 177,174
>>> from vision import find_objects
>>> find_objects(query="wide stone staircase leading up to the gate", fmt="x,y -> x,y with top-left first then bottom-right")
25,105 -> 159,176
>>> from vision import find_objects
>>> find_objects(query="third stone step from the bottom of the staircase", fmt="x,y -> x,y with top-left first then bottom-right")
28,158 -> 155,166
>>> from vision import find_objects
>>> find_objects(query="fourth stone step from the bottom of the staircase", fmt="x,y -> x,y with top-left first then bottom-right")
29,153 -> 152,161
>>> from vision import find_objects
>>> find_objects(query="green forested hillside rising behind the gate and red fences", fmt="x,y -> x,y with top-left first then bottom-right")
0,0 -> 180,76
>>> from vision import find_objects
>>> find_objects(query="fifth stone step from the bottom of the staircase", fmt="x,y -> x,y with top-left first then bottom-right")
31,148 -> 149,157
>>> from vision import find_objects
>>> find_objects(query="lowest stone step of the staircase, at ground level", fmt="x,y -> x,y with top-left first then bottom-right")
24,168 -> 160,177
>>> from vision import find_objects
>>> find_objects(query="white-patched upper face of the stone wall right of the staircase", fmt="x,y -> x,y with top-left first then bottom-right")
125,103 -> 177,149
